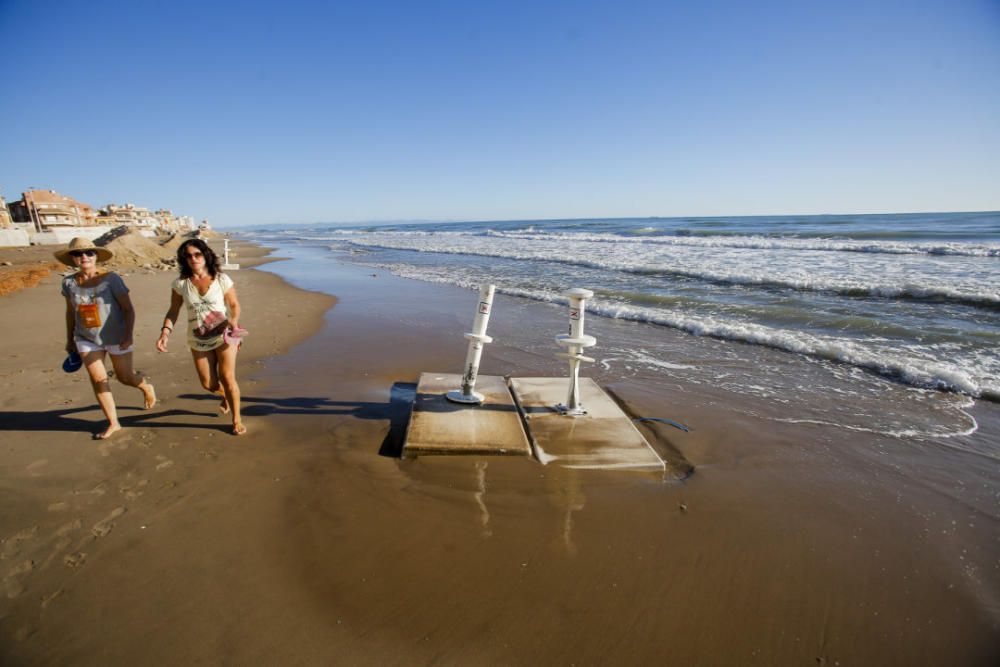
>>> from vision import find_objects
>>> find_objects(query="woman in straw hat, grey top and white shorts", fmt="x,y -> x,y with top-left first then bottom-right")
55,237 -> 156,440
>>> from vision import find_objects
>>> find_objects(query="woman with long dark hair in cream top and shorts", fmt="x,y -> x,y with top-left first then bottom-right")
156,239 -> 247,435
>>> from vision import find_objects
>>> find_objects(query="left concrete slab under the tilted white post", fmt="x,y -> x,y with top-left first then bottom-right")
403,373 -> 531,456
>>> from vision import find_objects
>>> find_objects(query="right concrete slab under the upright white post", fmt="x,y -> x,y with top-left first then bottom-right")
510,377 -> 666,471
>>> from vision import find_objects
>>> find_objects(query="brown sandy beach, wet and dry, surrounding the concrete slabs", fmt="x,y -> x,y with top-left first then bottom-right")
0,245 -> 1000,666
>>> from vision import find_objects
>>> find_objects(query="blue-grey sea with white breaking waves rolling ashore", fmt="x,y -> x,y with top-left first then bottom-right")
240,212 -> 1000,436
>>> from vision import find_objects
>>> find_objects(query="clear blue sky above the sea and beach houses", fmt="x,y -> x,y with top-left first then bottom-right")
0,0 -> 1000,226
